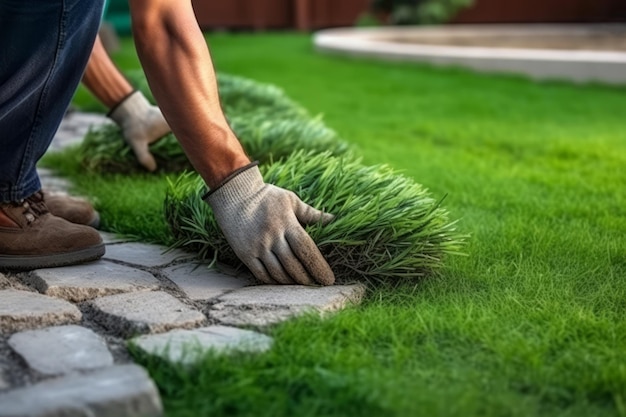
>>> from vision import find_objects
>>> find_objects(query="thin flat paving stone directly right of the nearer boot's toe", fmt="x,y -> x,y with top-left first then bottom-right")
104,242 -> 193,267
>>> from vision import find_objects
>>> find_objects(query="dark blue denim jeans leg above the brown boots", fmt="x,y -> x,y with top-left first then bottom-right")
0,0 -> 103,202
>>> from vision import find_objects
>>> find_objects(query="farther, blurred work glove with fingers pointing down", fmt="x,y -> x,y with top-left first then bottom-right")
108,91 -> 171,171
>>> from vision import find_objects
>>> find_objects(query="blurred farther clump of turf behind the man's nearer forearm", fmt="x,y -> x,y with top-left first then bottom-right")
81,72 -> 348,173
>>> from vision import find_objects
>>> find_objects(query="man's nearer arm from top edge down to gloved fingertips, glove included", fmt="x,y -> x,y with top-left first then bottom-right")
130,0 -> 335,285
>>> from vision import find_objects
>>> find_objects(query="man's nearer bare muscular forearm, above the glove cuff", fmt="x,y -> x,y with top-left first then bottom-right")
130,0 -> 250,187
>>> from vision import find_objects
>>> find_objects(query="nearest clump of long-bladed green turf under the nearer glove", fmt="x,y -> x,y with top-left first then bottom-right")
165,152 -> 465,283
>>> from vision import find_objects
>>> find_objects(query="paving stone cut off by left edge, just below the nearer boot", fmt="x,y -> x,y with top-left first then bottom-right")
0,290 -> 82,333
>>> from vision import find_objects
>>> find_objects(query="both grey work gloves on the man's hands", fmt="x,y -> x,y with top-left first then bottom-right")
109,91 -> 335,285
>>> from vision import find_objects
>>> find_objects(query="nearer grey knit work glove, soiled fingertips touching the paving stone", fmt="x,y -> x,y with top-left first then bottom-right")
204,164 -> 335,285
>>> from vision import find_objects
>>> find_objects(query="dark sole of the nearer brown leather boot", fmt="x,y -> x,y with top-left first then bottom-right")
0,243 -> 105,271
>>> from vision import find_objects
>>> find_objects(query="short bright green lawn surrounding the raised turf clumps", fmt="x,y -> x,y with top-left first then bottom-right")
46,34 -> 626,417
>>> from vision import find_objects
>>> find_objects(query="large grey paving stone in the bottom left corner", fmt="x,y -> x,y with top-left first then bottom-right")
0,365 -> 163,417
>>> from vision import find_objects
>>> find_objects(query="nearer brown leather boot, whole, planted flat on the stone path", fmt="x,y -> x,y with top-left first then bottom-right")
0,192 -> 105,270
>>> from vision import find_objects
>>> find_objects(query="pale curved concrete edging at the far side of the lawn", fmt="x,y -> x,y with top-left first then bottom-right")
313,25 -> 626,84
